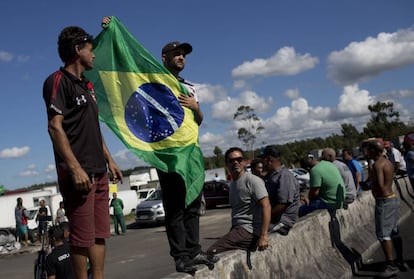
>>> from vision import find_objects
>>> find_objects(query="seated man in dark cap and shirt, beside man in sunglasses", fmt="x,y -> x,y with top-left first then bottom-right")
260,145 -> 300,235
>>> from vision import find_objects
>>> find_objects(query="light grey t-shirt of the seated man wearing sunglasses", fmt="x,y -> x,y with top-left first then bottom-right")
229,172 -> 268,236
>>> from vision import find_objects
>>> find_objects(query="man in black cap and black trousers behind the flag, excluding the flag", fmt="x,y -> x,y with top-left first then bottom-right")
158,42 -> 218,273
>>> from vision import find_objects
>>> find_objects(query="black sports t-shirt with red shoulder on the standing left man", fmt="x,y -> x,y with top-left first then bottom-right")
43,68 -> 106,174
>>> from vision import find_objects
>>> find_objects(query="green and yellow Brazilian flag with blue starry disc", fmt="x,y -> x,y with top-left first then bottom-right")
85,16 -> 204,205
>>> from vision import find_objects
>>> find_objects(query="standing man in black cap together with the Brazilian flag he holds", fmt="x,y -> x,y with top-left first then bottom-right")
92,16 -> 218,273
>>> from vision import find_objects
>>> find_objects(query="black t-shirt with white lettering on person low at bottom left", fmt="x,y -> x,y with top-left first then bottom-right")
46,243 -> 75,279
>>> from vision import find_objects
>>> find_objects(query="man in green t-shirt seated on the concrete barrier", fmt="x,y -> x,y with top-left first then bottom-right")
299,155 -> 346,217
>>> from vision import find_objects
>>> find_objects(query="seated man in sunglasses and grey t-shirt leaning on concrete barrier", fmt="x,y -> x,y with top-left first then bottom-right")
207,147 -> 271,257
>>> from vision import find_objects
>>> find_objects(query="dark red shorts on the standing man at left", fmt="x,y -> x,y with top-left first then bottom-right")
58,171 -> 111,247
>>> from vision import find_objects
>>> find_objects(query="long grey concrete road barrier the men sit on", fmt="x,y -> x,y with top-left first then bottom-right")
164,178 -> 414,279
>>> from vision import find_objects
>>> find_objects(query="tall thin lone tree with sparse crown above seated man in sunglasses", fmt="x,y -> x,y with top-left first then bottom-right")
233,105 -> 264,157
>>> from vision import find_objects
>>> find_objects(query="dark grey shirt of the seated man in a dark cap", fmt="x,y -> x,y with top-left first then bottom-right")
266,166 -> 300,228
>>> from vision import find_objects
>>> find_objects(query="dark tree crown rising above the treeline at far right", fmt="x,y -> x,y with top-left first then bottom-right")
364,102 -> 406,140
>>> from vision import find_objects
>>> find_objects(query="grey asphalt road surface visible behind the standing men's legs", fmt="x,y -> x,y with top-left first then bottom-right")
0,208 -> 230,279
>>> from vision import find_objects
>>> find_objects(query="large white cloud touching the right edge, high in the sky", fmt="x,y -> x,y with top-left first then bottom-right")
328,27 -> 414,85
